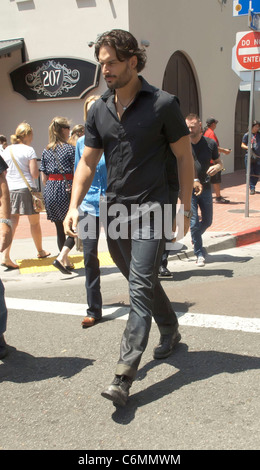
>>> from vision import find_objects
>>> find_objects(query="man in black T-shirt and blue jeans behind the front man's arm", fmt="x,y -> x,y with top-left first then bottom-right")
186,114 -> 223,267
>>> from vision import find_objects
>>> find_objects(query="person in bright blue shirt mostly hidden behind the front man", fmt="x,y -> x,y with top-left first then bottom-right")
74,96 -> 107,328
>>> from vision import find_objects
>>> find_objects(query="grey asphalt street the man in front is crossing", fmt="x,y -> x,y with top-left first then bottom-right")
0,243 -> 260,451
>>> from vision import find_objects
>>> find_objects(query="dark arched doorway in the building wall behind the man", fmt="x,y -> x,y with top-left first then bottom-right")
162,51 -> 200,116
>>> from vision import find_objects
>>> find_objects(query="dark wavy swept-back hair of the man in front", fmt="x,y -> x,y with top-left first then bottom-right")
95,29 -> 147,72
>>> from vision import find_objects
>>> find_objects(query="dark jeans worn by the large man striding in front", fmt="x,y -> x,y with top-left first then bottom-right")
107,214 -> 178,379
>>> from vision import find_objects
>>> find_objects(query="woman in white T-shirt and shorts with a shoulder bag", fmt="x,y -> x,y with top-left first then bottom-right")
2,122 -> 50,269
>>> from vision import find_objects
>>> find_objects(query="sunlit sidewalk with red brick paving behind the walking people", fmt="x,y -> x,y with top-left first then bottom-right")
1,170 -> 260,274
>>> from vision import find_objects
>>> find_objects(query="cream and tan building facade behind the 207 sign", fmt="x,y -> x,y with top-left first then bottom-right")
0,0 -> 260,172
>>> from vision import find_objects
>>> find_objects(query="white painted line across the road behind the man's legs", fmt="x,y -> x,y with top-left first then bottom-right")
5,297 -> 260,333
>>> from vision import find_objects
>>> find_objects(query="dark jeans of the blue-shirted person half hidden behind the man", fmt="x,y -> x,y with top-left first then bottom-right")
79,214 -> 102,320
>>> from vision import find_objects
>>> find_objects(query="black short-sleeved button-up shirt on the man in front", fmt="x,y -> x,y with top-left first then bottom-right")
85,77 -> 189,205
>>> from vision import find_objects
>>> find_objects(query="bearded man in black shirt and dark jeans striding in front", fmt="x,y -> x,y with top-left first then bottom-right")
65,30 -> 194,406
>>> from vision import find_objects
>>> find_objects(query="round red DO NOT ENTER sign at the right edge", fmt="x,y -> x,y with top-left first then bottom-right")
236,31 -> 260,70
